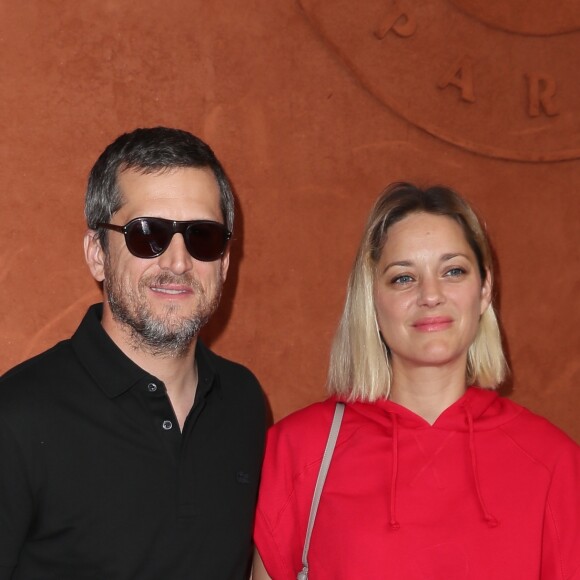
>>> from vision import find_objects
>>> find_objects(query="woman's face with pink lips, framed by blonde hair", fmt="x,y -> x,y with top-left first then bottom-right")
374,213 -> 491,374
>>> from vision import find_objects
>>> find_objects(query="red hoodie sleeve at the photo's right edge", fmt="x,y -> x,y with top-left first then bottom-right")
541,443 -> 580,580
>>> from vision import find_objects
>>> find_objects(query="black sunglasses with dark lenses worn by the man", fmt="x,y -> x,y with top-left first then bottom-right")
97,218 -> 232,262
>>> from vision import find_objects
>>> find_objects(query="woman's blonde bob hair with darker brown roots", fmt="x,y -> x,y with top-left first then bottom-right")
328,183 -> 507,401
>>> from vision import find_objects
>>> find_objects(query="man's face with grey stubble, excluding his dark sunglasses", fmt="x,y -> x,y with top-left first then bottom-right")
86,168 -> 229,357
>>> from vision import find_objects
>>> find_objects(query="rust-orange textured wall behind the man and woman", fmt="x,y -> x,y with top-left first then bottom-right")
0,0 -> 580,441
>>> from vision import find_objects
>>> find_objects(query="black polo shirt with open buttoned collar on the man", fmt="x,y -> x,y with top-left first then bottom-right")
0,305 -> 265,580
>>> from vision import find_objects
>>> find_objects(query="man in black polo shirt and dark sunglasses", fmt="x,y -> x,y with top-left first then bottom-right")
0,127 -> 265,580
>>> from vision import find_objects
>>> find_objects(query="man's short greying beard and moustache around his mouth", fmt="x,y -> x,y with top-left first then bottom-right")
104,264 -> 223,358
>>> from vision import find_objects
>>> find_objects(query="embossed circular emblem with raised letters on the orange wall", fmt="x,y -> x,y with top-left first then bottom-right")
299,0 -> 580,162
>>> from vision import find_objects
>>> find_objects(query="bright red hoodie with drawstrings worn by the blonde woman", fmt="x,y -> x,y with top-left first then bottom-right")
255,387 -> 580,580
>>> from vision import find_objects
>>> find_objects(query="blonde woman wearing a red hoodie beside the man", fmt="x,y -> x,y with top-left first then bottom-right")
254,183 -> 580,580
